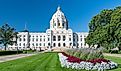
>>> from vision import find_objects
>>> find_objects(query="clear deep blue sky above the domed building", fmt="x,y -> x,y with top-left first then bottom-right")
0,0 -> 121,32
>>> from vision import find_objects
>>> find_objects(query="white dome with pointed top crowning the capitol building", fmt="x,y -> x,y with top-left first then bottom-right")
50,7 -> 68,29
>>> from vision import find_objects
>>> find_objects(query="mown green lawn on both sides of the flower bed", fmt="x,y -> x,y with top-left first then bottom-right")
0,53 -> 121,71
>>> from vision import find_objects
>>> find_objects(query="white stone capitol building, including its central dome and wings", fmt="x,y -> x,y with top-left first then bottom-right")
7,7 -> 88,50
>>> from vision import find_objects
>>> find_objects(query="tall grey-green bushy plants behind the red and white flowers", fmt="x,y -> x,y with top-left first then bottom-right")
64,48 -> 104,60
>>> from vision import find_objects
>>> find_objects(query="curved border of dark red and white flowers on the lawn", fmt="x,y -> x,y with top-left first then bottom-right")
58,52 -> 117,71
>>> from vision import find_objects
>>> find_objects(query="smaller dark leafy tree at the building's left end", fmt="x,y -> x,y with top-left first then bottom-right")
0,24 -> 17,50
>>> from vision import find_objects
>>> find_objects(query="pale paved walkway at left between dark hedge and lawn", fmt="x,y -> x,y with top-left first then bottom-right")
0,54 -> 35,62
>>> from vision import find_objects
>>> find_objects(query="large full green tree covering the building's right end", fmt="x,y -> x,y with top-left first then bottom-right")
85,6 -> 121,49
